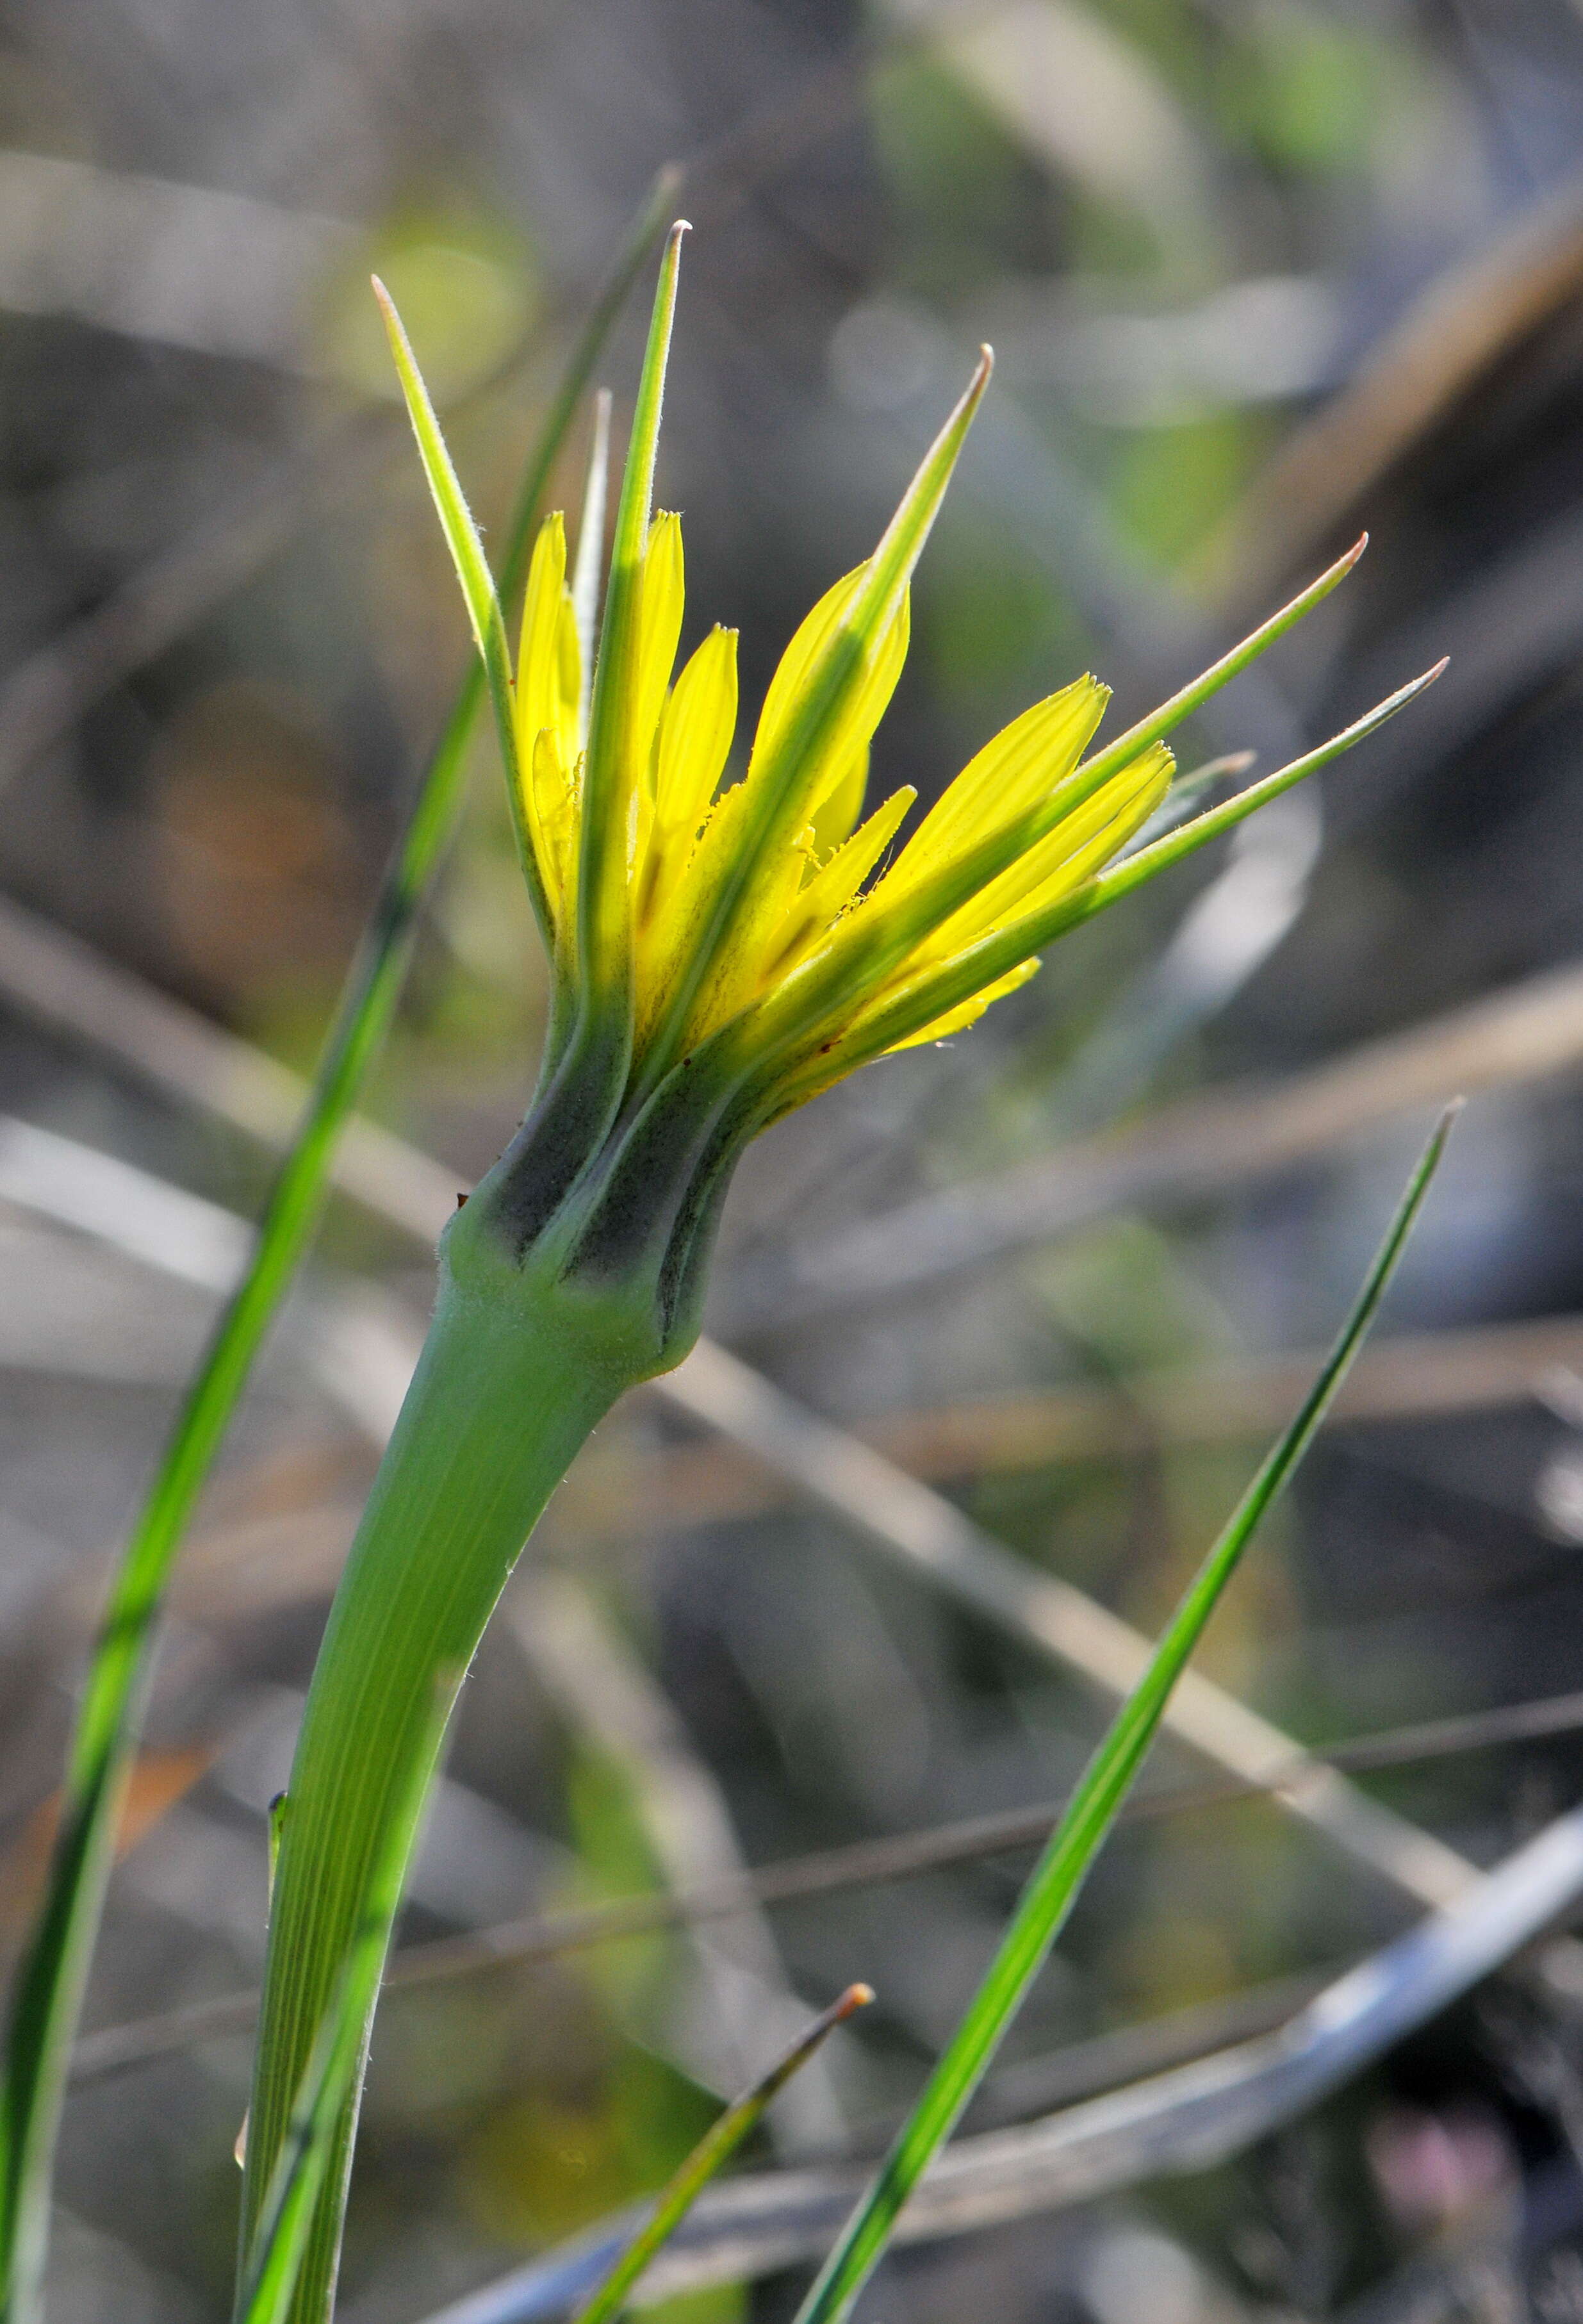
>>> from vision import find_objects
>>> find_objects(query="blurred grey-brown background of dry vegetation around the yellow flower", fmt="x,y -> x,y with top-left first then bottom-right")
0,0 -> 1583,2324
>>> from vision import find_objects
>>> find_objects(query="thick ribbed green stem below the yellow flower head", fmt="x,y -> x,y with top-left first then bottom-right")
244,1255 -> 628,2324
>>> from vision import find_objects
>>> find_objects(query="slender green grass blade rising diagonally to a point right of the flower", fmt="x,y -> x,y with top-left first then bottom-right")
795,1106 -> 1457,2324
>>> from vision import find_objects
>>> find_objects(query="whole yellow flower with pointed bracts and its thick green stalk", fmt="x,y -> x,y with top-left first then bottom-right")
244,230 -> 1427,2324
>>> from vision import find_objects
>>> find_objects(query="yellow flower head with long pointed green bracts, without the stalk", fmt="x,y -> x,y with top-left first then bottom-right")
386,227 -> 1434,1357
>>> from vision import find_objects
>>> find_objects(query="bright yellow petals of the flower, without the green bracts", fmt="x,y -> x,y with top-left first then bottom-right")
516,514 -> 1172,1078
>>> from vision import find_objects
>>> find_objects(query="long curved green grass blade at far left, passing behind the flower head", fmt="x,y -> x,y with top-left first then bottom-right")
0,172 -> 674,2324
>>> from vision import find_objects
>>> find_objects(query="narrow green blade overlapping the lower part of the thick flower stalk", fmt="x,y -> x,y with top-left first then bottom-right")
233,1671 -> 460,2324
